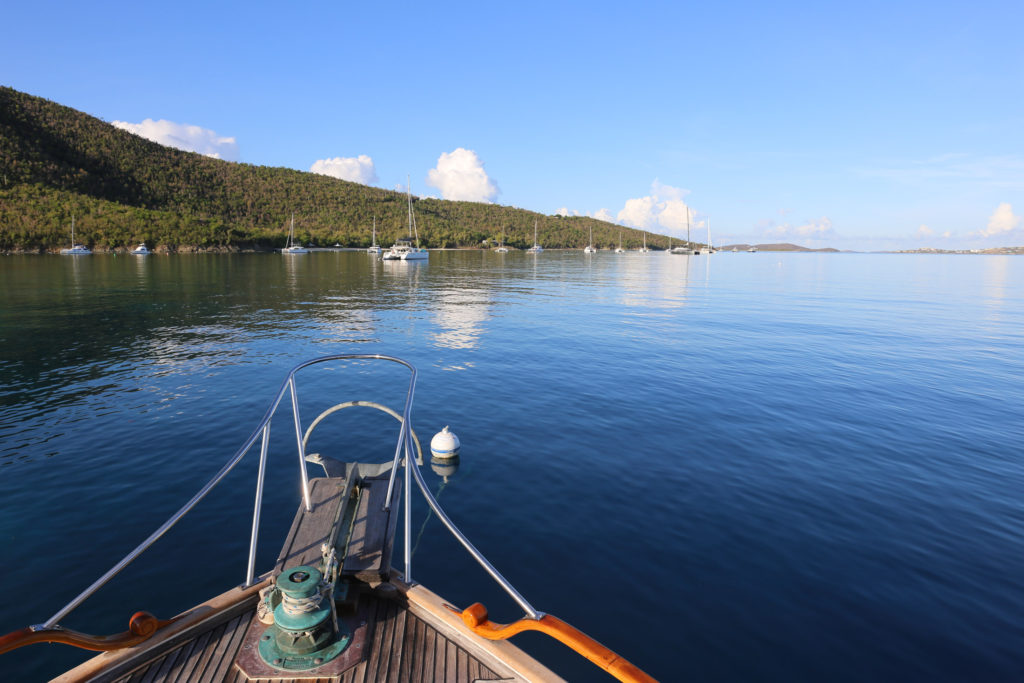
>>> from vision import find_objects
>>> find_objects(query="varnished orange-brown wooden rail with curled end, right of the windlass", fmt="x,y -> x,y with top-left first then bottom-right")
449,602 -> 656,683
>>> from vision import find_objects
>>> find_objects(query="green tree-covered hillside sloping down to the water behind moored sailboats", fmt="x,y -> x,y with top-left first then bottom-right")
0,87 -> 678,252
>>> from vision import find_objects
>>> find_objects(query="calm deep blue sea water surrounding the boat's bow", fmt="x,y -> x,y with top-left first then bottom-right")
0,252 -> 1024,681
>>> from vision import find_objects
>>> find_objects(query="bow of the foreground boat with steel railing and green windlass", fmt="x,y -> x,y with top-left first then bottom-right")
0,354 -> 653,683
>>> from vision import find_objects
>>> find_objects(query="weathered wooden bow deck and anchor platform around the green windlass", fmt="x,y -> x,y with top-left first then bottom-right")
56,470 -> 559,683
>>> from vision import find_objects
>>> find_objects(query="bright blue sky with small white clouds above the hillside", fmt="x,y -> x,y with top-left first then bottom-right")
0,1 -> 1024,250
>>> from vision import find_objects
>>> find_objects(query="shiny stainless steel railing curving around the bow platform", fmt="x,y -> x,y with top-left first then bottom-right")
32,353 -> 544,630
